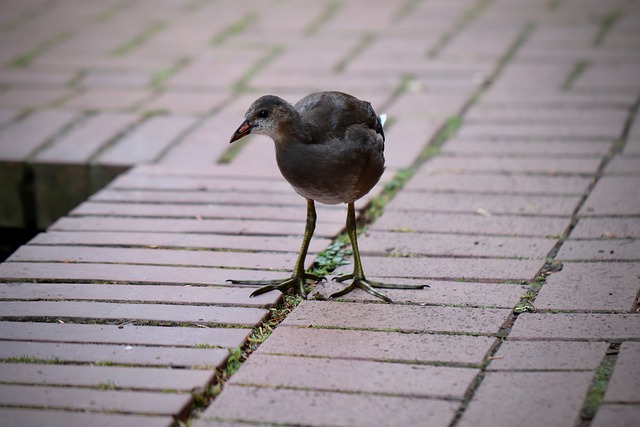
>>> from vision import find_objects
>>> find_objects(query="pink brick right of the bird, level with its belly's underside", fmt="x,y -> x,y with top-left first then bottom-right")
385,191 -> 580,216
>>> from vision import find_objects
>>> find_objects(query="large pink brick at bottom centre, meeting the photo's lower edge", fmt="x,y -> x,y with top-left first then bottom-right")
202,385 -> 459,426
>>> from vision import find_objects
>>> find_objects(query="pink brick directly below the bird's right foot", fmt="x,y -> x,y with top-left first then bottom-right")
282,301 -> 511,334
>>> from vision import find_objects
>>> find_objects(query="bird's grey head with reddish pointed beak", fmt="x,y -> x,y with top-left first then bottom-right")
229,95 -> 296,142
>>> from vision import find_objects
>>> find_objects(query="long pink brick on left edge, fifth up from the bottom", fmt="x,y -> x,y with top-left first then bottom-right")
0,322 -> 251,348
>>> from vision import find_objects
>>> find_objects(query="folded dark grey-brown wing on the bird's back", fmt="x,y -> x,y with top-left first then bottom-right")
294,92 -> 384,139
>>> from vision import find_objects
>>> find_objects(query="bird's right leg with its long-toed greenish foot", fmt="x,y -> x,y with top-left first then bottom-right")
331,202 -> 428,302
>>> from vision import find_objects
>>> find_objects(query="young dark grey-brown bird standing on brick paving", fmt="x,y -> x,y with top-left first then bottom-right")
229,91 -> 424,303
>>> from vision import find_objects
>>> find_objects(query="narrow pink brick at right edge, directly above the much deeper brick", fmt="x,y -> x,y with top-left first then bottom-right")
556,239 -> 640,261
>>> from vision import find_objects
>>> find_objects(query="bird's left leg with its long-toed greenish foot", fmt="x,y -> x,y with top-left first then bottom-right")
227,199 -> 323,298
